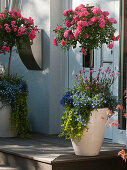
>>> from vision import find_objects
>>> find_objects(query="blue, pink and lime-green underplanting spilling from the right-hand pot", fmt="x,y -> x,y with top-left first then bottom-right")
61,68 -> 120,140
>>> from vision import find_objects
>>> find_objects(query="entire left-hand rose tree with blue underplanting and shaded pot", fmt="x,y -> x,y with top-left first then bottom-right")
0,9 -> 38,137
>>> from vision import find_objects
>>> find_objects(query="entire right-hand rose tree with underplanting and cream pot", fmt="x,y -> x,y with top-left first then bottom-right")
53,4 -> 120,156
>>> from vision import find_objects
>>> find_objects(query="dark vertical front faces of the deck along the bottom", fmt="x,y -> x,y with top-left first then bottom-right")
0,151 -> 127,170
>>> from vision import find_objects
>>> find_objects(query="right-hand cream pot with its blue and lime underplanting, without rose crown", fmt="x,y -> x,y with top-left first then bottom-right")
61,68 -> 120,156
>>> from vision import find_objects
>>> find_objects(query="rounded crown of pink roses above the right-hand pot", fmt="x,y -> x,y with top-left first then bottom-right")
53,4 -> 120,55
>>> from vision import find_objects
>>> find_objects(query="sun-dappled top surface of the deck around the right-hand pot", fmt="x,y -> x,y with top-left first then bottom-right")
0,134 -> 125,163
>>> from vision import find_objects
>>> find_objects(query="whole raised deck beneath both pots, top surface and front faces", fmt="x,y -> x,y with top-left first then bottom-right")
0,135 -> 127,170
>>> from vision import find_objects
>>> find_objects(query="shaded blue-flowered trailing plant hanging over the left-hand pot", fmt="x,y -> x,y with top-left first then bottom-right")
0,72 -> 31,138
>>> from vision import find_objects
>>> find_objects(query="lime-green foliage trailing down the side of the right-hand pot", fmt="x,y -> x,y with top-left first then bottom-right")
60,106 -> 90,140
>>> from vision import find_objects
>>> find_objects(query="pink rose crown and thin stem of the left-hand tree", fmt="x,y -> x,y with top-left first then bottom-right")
0,9 -> 38,76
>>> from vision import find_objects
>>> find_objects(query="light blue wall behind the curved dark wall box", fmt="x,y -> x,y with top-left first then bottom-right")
20,0 -> 50,133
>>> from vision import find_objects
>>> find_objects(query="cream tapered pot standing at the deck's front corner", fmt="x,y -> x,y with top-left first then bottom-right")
71,108 -> 108,156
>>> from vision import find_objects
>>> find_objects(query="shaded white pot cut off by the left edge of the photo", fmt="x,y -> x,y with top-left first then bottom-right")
0,102 -> 17,137
